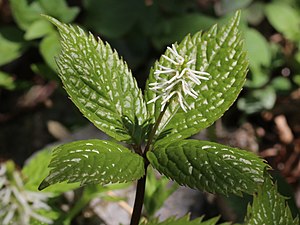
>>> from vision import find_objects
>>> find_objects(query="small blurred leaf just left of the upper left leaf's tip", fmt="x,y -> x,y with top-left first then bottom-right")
24,20 -> 53,40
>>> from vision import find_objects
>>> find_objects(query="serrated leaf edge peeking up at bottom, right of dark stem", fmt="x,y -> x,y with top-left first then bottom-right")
140,215 -> 219,225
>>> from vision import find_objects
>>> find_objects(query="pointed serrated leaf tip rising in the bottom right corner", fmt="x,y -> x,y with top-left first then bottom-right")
245,177 -> 299,225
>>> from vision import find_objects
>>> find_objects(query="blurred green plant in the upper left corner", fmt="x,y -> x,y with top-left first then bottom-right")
0,0 -> 79,90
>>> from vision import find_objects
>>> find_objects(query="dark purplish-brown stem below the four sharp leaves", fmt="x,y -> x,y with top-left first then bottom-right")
130,158 -> 149,225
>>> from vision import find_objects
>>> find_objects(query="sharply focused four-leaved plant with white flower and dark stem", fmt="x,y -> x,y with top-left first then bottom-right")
39,12 -> 297,225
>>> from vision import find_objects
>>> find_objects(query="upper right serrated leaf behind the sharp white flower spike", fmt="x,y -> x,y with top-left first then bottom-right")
146,12 -> 248,144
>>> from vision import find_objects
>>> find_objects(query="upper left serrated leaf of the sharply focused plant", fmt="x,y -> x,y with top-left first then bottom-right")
43,17 -> 147,141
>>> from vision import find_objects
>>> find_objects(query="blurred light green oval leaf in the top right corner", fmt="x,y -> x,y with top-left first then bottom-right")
265,1 -> 300,41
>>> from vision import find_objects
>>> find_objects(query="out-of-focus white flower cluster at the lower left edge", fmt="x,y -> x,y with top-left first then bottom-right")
0,161 -> 52,225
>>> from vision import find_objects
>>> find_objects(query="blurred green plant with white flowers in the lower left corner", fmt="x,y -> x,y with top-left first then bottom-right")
0,148 -> 134,225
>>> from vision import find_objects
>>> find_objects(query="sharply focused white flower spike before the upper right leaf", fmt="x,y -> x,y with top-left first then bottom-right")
147,44 -> 210,112
